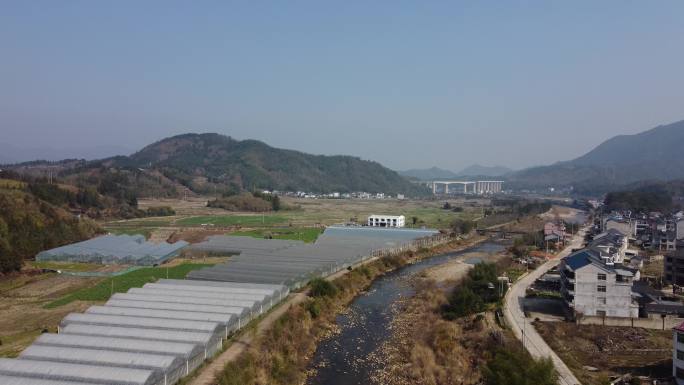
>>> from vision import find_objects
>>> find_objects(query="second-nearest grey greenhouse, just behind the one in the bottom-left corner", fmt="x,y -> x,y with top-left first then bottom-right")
19,345 -> 186,385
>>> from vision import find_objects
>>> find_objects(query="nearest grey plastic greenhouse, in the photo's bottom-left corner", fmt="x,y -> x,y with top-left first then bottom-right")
0,358 -> 164,385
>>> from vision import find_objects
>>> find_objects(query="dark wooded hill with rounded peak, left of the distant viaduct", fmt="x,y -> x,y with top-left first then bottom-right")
106,134 -> 428,195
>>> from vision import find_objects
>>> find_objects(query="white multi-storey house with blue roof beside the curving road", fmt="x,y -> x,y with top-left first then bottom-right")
559,249 -> 639,318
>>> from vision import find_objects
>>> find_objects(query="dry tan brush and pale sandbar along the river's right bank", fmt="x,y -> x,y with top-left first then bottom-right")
373,248 -> 516,385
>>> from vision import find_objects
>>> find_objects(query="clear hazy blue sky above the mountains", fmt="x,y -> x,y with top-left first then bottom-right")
0,0 -> 684,170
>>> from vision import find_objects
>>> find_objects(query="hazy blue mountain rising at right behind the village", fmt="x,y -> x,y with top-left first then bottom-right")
507,121 -> 684,193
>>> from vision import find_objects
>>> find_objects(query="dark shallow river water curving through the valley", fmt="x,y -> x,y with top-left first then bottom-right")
306,242 -> 504,385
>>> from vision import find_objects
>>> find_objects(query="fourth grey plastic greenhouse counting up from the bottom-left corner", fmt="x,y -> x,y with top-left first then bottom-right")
60,323 -> 223,358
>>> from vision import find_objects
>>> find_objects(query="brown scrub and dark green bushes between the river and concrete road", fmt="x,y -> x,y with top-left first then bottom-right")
374,261 -> 558,385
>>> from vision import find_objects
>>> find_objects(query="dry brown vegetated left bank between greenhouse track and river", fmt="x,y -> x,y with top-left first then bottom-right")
211,237 -> 483,385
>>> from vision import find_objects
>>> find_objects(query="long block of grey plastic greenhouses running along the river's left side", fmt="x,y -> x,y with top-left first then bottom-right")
0,229 -> 440,385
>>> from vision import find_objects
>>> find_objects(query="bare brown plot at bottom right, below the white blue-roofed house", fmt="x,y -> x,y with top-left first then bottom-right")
534,322 -> 672,385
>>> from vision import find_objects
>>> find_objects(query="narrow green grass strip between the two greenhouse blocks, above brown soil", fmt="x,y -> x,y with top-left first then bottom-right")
44,263 -> 212,309
